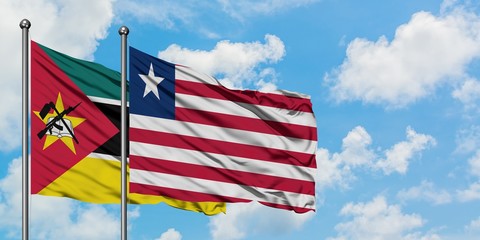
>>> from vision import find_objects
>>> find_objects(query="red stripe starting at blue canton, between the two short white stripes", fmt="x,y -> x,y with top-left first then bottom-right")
175,79 -> 313,113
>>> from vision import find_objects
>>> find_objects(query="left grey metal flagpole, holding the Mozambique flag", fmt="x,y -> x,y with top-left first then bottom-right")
20,19 -> 31,240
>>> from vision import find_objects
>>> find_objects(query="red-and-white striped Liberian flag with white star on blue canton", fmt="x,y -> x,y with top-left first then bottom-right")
129,47 -> 317,213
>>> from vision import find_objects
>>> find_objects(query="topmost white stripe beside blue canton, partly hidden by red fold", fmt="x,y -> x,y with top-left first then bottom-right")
175,65 -> 310,99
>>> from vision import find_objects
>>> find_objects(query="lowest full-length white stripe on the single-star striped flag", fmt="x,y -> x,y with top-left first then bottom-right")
130,169 -> 315,209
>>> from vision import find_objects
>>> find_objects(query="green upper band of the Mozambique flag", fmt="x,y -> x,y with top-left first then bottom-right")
39,44 -> 128,100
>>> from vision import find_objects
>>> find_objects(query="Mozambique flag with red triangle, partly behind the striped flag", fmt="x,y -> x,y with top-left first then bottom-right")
31,41 -> 226,215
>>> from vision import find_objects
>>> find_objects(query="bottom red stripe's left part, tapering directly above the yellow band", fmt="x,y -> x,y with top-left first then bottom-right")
130,182 -> 252,202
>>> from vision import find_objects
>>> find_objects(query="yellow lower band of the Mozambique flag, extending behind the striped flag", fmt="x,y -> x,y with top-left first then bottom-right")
38,157 -> 226,215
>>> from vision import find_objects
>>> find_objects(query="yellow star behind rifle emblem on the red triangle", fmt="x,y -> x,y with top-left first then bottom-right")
33,93 -> 85,154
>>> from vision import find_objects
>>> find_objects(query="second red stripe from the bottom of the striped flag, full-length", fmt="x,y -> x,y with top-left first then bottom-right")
130,155 -> 315,195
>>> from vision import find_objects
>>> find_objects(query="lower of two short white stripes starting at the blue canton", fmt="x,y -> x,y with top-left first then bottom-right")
175,93 -> 316,127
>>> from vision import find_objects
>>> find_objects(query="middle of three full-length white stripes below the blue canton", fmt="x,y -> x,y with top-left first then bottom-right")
130,142 -> 315,182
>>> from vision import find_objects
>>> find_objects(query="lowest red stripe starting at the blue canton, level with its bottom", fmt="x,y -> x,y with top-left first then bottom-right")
175,107 -> 317,141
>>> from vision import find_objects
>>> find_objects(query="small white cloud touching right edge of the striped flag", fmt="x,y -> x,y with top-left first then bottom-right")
316,126 -> 435,189
